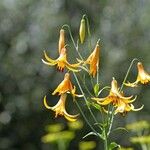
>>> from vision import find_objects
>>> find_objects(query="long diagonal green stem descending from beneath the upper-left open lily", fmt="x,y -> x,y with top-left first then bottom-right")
73,72 -> 98,123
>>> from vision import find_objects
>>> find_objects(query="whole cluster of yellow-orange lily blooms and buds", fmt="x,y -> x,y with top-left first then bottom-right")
42,17 -> 150,121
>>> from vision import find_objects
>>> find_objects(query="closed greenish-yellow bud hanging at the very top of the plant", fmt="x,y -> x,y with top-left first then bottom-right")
79,17 -> 85,44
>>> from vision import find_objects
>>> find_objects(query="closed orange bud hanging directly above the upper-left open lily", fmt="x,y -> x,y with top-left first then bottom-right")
58,29 -> 65,54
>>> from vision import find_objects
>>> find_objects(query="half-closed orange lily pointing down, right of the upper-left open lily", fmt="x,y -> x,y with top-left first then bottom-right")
85,42 -> 100,77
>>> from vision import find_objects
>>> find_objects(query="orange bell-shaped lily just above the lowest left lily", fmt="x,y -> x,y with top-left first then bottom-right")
52,73 -> 83,97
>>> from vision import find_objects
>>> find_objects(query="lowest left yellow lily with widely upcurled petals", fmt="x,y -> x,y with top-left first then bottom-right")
44,93 -> 79,121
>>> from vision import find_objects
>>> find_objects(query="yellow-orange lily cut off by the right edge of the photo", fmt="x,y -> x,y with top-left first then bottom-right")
125,62 -> 150,87
